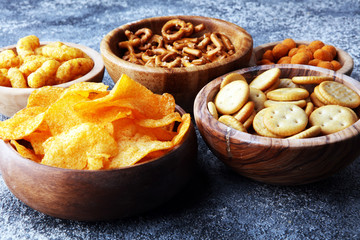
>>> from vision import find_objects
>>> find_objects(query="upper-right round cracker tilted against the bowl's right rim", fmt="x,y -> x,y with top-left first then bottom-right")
319,81 -> 360,108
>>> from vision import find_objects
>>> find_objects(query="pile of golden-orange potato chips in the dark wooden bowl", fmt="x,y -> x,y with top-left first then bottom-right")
0,75 -> 191,170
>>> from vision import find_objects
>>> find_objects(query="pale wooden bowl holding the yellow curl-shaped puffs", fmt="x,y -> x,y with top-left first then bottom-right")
0,42 -> 105,117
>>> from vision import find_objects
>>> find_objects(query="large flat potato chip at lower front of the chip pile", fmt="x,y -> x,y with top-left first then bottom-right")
41,123 -> 118,169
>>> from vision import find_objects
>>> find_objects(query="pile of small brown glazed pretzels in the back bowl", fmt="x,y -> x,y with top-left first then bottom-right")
118,19 -> 235,68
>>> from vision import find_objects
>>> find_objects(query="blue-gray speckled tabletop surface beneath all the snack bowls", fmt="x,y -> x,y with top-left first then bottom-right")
0,0 -> 360,239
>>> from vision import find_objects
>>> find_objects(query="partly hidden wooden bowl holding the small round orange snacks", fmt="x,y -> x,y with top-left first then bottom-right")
251,41 -> 354,76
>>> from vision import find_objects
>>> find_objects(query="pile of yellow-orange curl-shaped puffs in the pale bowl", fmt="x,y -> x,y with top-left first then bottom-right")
0,35 -> 94,88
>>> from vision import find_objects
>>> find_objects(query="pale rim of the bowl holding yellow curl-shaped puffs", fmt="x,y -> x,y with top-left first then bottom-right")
0,41 -> 105,91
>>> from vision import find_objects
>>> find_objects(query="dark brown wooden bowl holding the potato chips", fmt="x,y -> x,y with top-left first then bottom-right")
0,107 -> 197,221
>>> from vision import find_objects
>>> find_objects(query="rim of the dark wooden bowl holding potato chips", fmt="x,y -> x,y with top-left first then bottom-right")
0,105 -> 194,174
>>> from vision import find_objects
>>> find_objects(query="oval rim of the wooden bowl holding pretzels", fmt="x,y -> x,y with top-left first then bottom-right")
100,15 -> 253,74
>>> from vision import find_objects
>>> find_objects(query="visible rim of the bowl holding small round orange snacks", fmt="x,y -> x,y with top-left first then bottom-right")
253,40 -> 354,76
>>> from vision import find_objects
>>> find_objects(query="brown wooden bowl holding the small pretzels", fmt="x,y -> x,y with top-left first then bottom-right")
100,16 -> 253,111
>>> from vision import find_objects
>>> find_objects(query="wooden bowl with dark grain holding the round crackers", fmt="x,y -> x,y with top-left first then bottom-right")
194,64 -> 360,185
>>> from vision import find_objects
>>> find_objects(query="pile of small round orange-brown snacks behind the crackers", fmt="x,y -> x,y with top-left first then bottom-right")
257,38 -> 342,71
